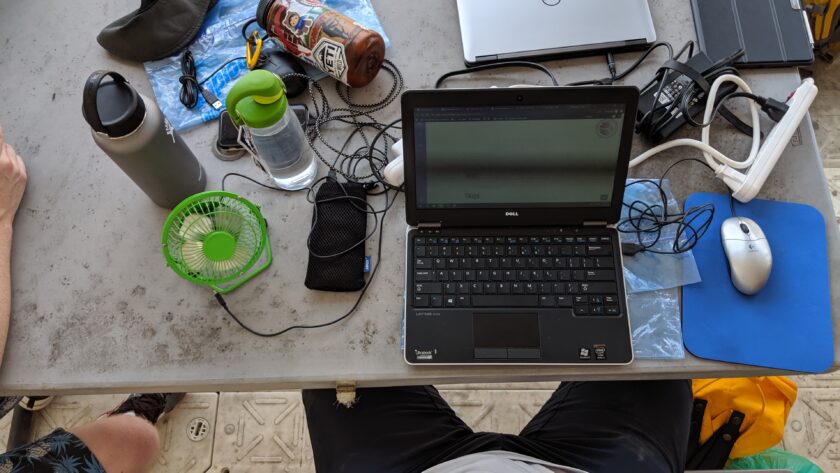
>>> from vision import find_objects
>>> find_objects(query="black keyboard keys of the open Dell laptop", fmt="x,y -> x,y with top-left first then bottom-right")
411,234 -> 622,316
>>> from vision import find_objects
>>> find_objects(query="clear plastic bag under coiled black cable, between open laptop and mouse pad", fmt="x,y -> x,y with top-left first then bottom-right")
620,179 -> 700,294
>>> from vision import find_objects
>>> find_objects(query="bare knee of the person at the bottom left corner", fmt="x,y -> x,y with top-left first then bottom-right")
70,415 -> 158,473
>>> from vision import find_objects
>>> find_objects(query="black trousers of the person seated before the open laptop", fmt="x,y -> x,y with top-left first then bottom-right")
303,381 -> 692,473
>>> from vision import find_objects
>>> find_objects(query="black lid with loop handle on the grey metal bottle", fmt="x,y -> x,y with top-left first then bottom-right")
82,71 -> 146,138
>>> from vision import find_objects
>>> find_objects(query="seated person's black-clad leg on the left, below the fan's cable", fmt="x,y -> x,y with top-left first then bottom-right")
303,386 -> 480,473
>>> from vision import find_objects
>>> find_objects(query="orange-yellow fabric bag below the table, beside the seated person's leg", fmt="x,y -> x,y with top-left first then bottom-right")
692,376 -> 796,458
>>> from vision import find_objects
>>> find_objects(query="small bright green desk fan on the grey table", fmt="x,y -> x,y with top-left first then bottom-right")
161,191 -> 271,294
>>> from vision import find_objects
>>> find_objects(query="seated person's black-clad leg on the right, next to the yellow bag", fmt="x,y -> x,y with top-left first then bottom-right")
520,380 -> 692,473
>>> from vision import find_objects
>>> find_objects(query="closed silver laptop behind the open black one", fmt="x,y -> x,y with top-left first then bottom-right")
458,0 -> 656,65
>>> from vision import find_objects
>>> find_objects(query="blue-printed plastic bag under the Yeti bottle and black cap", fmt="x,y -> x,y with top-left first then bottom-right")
143,0 -> 390,131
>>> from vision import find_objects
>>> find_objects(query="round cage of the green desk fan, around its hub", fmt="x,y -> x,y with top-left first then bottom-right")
164,192 -> 265,285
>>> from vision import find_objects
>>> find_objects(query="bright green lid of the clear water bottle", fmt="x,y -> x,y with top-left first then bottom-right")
225,69 -> 289,128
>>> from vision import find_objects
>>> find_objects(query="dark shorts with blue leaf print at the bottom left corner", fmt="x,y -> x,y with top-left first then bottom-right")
0,429 -> 105,473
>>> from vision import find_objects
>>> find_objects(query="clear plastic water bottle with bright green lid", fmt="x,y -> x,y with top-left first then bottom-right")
226,70 -> 318,191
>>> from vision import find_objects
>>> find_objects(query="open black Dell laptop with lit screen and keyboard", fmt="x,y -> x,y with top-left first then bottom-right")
402,86 -> 639,364
